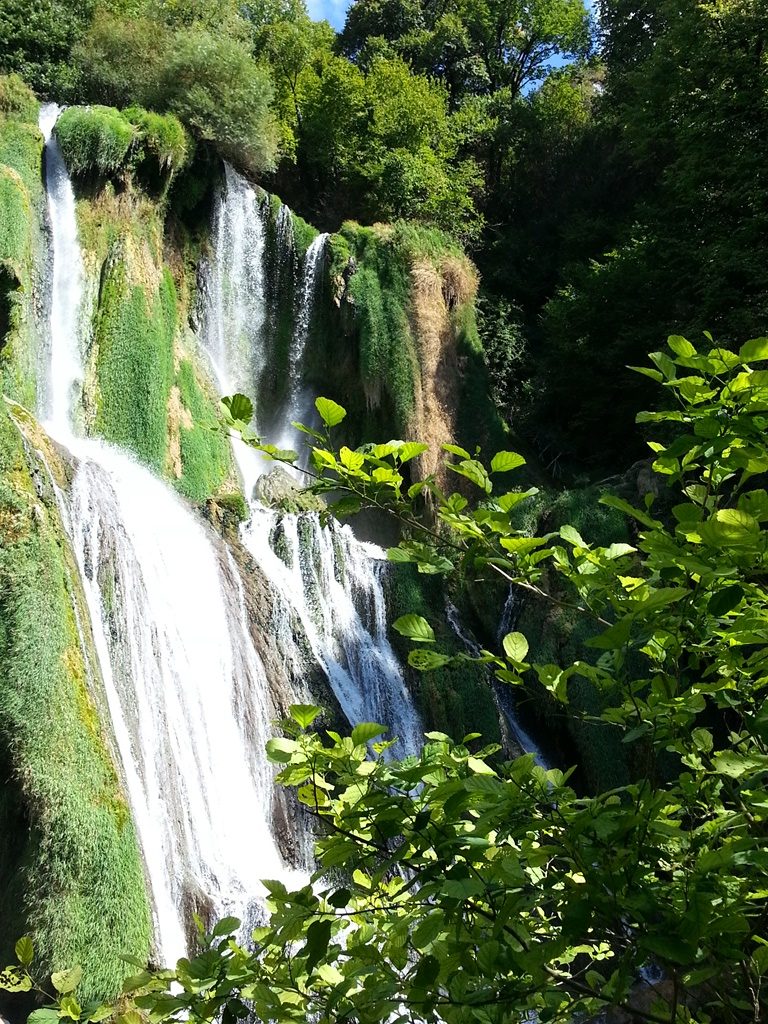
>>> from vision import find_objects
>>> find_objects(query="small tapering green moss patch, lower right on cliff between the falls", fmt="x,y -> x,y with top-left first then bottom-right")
176,359 -> 231,502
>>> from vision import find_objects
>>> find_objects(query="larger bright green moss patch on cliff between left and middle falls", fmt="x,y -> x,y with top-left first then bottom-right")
95,252 -> 176,473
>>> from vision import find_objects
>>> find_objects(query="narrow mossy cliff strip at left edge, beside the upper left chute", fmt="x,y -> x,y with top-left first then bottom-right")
0,83 -> 44,408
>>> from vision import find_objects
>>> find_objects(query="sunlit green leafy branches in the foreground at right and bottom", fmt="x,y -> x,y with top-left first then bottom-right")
9,337 -> 768,1024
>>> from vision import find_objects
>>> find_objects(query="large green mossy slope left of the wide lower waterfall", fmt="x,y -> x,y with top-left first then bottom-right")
0,403 -> 151,999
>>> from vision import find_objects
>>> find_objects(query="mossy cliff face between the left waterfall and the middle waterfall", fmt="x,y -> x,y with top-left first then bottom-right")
70,158 -> 237,503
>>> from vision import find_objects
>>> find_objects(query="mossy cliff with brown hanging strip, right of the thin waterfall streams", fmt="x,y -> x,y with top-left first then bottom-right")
308,223 -> 504,473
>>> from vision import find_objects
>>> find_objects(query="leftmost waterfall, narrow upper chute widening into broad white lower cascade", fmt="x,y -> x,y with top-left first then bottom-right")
41,105 -> 296,962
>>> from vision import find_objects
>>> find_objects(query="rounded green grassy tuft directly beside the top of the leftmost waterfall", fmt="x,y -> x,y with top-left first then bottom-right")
55,105 -> 136,175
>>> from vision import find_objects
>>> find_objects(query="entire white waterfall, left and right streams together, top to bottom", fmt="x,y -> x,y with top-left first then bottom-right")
34,104 -> 421,963
